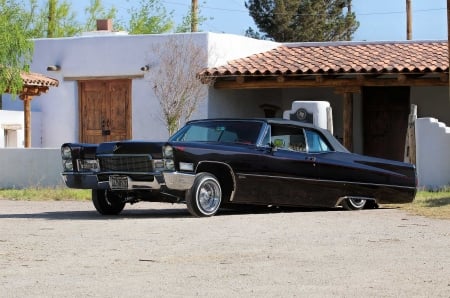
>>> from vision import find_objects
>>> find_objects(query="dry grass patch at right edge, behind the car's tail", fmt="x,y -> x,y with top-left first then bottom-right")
387,189 -> 450,219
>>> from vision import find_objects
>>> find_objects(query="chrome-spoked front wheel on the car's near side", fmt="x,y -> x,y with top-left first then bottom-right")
186,173 -> 222,217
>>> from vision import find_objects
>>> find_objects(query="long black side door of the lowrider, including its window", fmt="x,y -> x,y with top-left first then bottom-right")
232,124 -> 320,206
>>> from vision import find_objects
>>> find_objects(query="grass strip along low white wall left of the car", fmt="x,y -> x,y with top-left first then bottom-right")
0,187 -> 91,201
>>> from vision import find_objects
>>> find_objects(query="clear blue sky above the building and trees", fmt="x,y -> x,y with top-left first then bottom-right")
68,0 -> 448,41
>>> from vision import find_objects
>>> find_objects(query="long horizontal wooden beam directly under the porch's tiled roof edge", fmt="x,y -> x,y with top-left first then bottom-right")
214,75 -> 448,89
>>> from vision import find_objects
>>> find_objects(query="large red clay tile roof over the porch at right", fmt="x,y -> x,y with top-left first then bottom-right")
199,41 -> 449,77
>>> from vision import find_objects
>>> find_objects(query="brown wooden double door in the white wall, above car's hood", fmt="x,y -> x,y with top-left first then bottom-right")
79,79 -> 131,144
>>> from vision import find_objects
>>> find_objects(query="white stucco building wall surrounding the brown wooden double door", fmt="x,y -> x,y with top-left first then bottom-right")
3,33 -> 278,147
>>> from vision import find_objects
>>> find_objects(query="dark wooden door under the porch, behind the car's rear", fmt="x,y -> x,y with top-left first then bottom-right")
363,87 -> 410,161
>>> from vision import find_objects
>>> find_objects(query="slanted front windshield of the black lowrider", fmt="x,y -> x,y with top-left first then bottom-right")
170,121 -> 263,145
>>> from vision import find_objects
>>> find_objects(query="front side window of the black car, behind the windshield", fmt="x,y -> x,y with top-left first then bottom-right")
270,125 -> 307,152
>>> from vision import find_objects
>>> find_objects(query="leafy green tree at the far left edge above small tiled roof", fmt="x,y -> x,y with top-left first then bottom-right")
0,0 -> 33,95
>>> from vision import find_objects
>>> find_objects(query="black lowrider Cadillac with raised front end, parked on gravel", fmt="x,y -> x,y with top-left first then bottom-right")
61,119 -> 417,217
